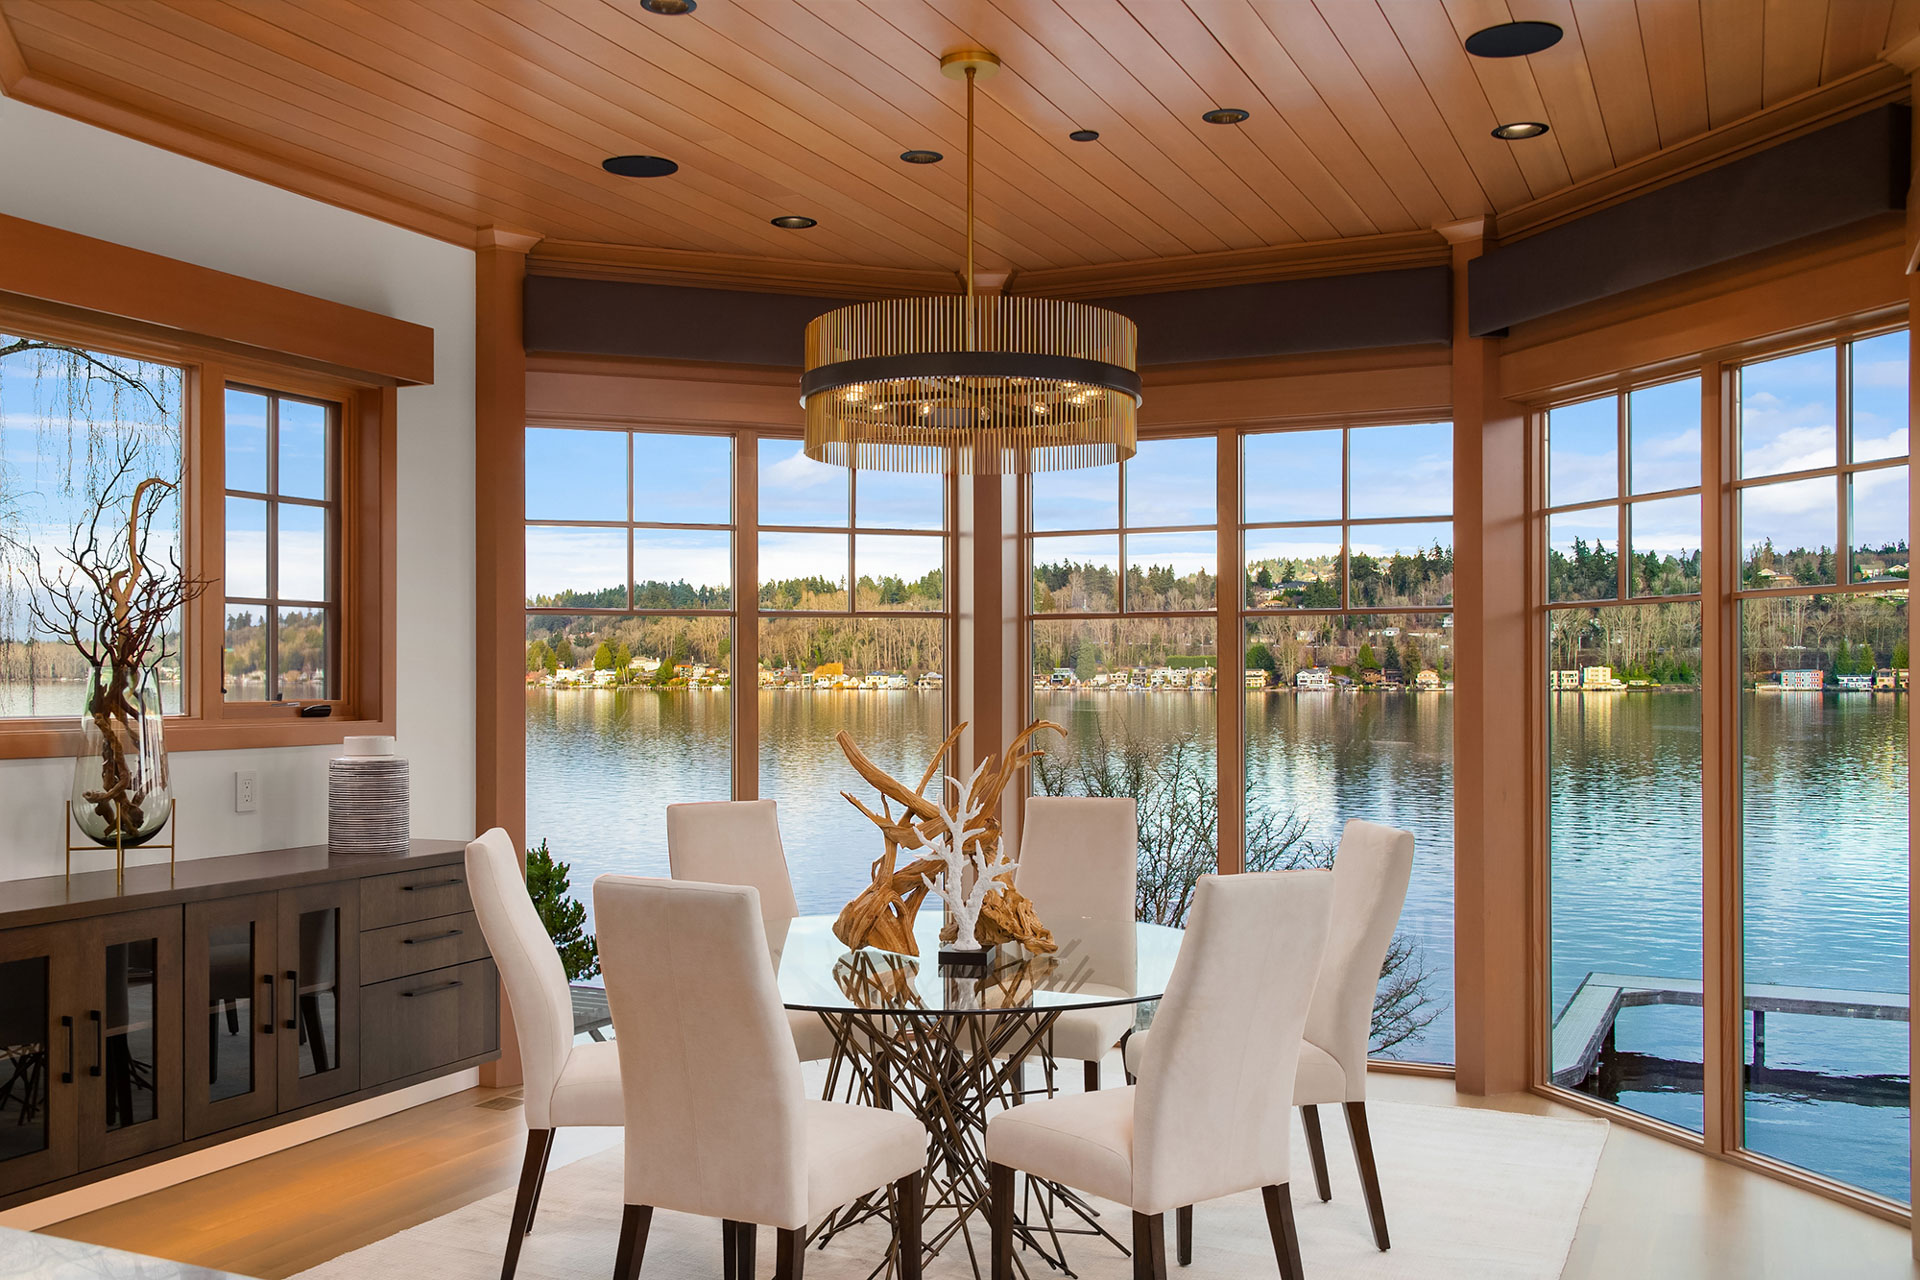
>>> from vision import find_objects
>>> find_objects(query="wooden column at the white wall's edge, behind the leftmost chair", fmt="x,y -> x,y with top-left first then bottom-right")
474,226 -> 540,1088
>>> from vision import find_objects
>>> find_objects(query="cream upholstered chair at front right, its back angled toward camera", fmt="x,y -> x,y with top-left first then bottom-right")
987,871 -> 1332,1280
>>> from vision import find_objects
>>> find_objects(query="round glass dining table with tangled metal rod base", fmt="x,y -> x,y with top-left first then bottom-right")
768,910 -> 1181,1274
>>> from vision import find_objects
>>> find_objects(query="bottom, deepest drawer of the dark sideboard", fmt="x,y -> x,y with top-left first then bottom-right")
361,960 -> 499,1088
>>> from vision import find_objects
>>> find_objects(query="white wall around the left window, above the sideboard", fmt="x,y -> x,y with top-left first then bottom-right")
0,96 -> 474,882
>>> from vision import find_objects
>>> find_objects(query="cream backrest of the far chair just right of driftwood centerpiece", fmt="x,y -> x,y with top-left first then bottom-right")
1014,796 -> 1140,923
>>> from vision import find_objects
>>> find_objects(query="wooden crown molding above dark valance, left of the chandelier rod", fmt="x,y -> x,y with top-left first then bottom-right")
526,240 -> 962,297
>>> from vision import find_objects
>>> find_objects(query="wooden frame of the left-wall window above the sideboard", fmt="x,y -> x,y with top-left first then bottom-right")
0,307 -> 397,760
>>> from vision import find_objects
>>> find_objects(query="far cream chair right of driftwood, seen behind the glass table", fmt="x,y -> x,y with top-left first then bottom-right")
1014,796 -> 1140,1092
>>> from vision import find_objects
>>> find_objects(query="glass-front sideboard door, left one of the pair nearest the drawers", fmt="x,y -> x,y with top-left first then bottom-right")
184,892 -> 286,1138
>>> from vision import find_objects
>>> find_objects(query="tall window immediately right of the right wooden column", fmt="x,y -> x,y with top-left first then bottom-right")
1546,378 -> 1703,1132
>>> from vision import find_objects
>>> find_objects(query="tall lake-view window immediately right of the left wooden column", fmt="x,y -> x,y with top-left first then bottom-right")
526,426 -> 735,927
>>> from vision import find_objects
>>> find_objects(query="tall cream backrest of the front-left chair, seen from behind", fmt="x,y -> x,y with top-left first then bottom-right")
593,875 -> 806,1230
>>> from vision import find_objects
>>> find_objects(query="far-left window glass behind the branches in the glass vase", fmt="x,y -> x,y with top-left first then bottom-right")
0,332 -> 186,720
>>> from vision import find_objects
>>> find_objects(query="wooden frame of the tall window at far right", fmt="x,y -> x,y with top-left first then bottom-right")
1524,318 -> 1920,1224
